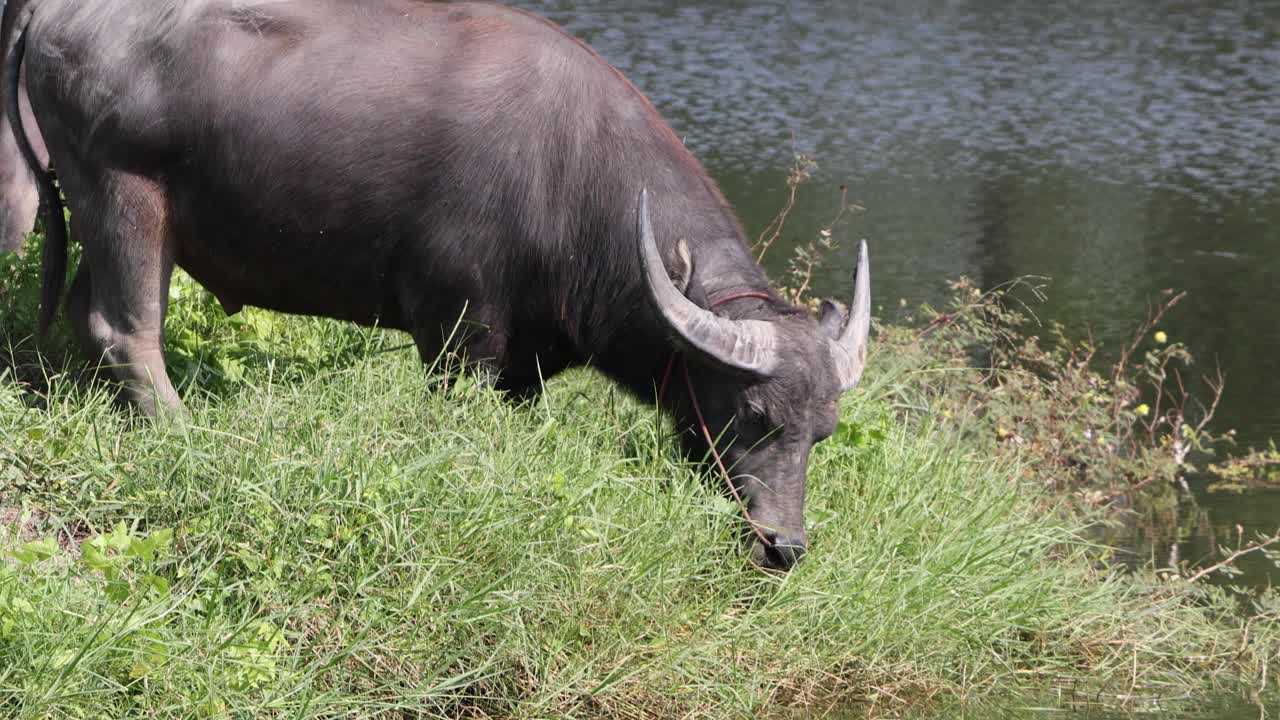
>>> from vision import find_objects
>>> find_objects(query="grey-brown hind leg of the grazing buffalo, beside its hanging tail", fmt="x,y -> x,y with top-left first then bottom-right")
68,174 -> 184,415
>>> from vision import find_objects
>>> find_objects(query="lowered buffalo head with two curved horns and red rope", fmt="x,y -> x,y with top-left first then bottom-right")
639,192 -> 870,570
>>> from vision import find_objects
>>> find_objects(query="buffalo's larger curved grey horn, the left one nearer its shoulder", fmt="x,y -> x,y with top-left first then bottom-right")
639,190 -> 778,377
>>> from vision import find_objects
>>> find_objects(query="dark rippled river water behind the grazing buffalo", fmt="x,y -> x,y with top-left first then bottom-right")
518,0 -> 1280,712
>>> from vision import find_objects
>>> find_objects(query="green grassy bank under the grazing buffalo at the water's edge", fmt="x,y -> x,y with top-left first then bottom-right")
0,237 -> 1280,717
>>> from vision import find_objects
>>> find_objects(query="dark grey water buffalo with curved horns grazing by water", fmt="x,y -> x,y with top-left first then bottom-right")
0,0 -> 870,569
